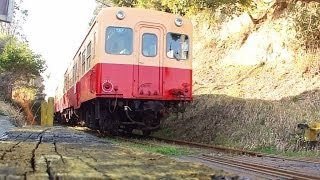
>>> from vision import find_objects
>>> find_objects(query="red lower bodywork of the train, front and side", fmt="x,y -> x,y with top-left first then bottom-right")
55,63 -> 192,112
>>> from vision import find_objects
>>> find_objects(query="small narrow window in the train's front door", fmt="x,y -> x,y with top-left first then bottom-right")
142,33 -> 158,57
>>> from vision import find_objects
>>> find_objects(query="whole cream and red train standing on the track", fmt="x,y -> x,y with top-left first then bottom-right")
54,7 -> 192,135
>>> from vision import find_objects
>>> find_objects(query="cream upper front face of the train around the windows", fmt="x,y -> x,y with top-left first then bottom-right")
94,7 -> 192,69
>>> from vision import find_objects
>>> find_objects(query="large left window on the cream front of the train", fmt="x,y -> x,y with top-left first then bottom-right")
105,27 -> 133,55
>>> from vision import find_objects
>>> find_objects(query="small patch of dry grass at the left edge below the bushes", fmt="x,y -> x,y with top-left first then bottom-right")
0,100 -> 25,126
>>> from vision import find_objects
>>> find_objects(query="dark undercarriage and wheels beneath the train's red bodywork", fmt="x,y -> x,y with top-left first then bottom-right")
55,98 -> 185,136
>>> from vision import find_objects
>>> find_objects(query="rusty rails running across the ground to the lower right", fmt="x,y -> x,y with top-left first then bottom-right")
117,137 -> 320,180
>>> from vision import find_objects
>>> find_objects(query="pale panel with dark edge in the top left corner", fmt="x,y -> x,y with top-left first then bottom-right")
0,0 -> 14,23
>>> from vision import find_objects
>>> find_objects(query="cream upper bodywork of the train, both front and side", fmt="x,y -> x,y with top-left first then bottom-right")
63,7 -> 192,92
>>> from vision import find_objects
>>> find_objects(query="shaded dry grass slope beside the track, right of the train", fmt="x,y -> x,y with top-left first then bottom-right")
164,91 -> 320,150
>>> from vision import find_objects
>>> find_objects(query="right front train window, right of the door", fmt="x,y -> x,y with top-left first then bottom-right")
167,33 -> 189,60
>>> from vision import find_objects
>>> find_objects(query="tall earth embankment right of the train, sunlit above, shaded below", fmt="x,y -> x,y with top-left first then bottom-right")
160,1 -> 320,150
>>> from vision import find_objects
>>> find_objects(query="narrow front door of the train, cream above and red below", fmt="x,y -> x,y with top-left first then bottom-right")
133,25 -> 163,98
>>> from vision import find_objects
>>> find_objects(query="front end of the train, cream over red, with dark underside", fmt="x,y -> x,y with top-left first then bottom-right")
88,8 -> 192,134
